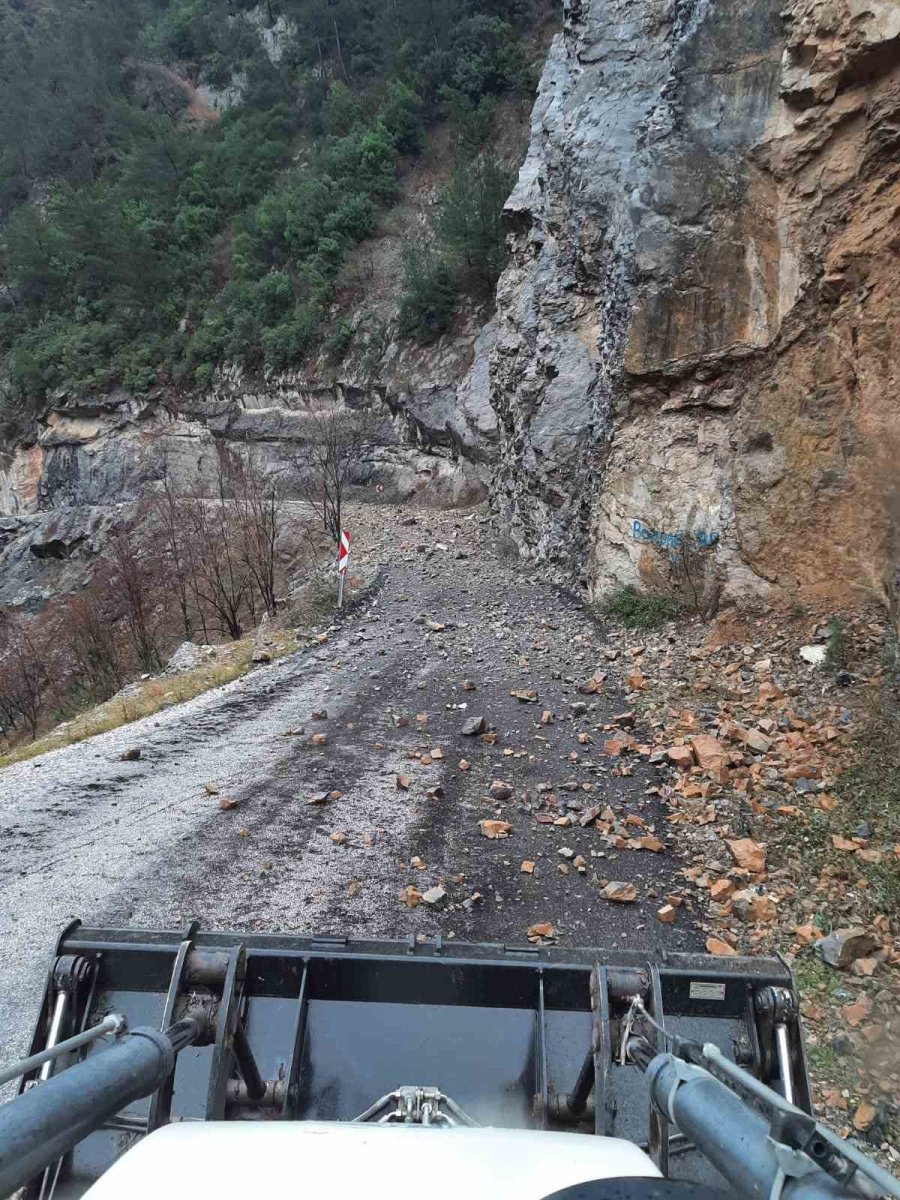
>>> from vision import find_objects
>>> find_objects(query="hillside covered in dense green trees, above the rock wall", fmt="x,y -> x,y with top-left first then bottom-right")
0,0 -> 535,415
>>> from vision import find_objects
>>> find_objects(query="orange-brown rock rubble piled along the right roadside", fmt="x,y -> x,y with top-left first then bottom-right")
605,612 -> 900,1170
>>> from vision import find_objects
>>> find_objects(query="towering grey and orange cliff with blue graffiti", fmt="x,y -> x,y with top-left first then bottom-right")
488,0 -> 900,609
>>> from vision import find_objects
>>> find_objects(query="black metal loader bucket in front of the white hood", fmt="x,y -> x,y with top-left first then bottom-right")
14,923 -> 810,1200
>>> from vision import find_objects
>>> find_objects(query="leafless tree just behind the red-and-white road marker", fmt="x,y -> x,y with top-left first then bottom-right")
293,406 -> 373,542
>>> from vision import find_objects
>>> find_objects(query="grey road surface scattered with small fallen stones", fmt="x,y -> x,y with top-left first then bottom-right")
0,509 -> 700,1075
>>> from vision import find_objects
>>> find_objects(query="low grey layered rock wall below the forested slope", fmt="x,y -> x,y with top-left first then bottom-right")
0,314 -> 497,610
